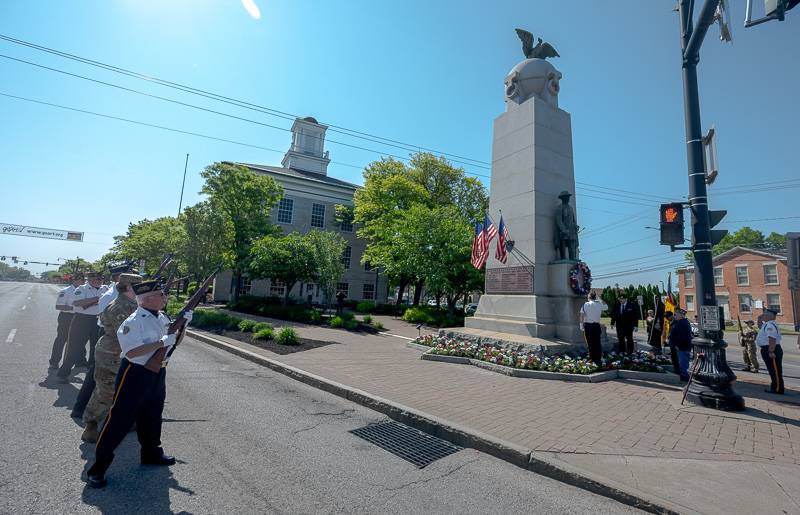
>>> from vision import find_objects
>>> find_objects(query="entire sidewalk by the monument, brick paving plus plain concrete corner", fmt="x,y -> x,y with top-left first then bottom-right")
186,314 -> 800,514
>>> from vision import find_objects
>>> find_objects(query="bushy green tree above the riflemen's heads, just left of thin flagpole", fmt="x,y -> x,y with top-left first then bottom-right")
111,216 -> 186,275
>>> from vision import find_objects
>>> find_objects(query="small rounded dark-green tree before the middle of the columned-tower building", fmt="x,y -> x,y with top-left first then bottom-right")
248,232 -> 318,306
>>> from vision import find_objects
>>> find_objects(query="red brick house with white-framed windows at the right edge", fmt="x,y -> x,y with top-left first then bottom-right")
678,247 -> 797,326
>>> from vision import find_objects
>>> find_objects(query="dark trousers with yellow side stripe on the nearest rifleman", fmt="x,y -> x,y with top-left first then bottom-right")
87,358 -> 167,475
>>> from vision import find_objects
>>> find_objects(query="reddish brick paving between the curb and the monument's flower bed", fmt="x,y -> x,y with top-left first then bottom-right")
197,310 -> 800,513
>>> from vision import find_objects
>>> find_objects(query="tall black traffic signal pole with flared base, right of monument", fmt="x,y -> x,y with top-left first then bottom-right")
678,0 -> 744,411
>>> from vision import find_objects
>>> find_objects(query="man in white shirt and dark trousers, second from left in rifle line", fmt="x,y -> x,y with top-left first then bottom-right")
58,272 -> 106,382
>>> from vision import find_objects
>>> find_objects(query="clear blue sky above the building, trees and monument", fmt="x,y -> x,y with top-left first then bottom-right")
0,0 -> 800,286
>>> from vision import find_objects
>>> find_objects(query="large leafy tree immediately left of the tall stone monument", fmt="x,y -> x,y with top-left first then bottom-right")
354,153 -> 488,304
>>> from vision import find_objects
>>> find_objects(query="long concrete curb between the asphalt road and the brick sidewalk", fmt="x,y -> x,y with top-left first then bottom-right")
186,330 -> 686,515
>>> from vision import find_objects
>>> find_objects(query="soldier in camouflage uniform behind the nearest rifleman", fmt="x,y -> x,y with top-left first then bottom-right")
81,274 -> 142,443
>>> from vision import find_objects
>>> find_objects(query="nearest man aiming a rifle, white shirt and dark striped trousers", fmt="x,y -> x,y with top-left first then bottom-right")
86,280 -> 192,488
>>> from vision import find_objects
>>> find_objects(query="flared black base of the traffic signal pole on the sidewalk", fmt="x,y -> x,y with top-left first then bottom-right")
686,338 -> 745,411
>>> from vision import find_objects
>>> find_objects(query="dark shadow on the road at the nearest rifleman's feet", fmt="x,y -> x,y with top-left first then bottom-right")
80,433 -> 194,515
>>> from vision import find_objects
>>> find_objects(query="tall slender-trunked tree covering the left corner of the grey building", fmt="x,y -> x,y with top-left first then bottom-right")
200,163 -> 283,301
